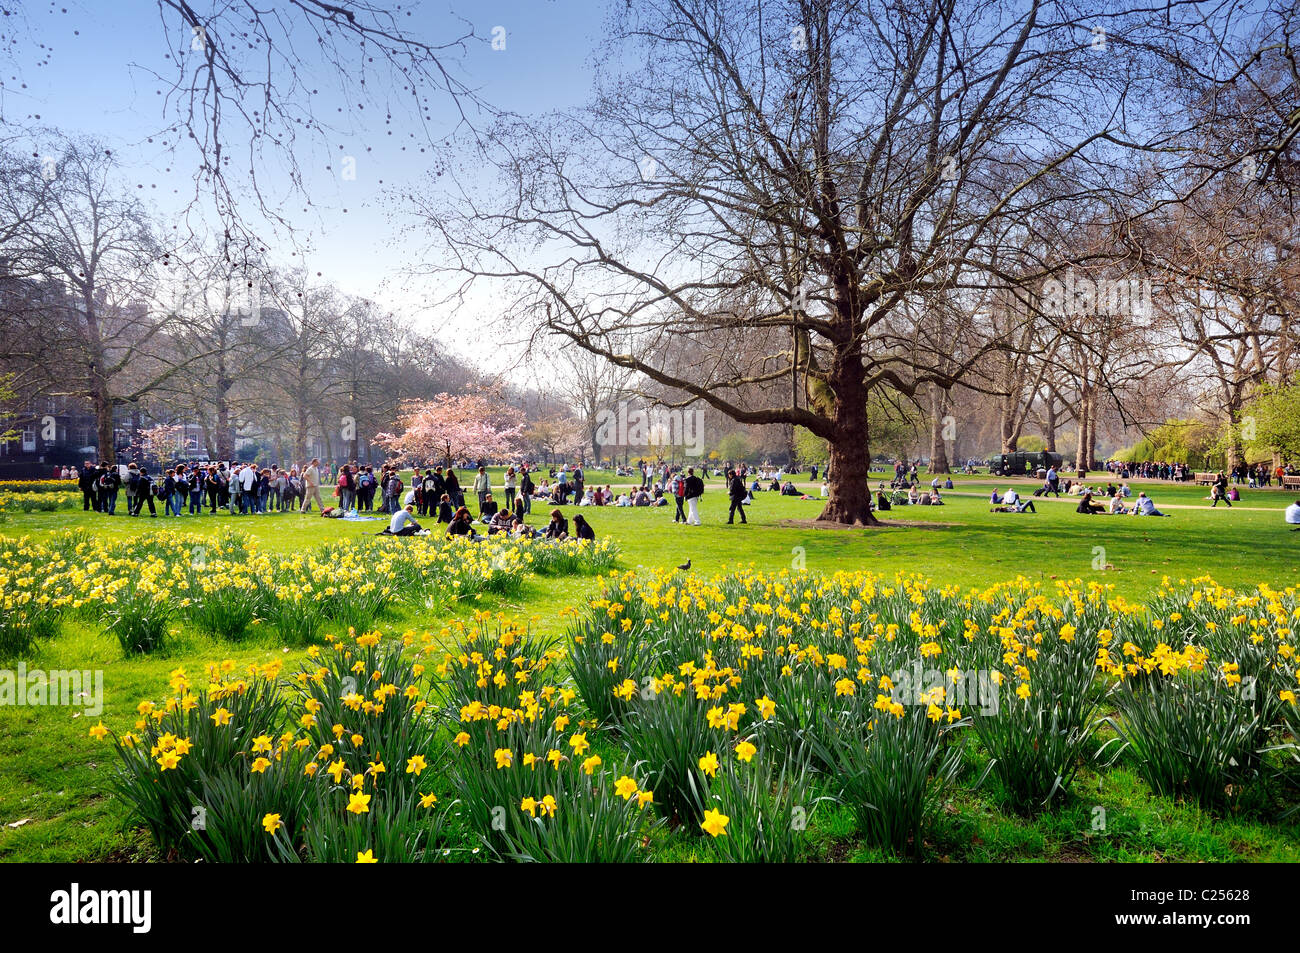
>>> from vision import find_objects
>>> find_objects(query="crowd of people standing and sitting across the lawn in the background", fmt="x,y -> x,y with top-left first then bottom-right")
56,447 -> 1300,530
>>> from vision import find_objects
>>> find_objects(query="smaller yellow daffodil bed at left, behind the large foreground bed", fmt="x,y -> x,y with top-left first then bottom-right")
0,529 -> 618,659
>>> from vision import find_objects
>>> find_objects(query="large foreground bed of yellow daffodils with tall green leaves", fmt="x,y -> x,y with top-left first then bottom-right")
78,571 -> 1300,862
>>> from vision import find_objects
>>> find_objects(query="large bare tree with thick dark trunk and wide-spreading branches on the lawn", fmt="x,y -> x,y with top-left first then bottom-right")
407,0 -> 1242,524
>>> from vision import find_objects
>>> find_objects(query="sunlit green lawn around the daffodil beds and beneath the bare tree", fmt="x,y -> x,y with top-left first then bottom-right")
0,472 -> 1300,861
